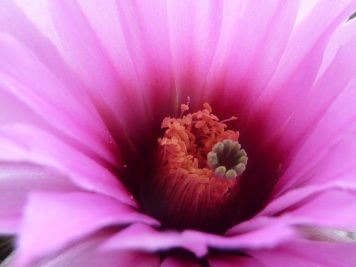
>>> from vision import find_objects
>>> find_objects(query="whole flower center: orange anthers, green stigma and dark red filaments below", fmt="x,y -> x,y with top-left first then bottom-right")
143,103 -> 247,232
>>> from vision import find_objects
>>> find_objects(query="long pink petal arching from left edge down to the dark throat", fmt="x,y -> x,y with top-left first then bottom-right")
0,125 -> 134,204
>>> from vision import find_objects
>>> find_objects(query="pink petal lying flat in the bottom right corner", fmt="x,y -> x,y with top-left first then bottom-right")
249,240 -> 356,267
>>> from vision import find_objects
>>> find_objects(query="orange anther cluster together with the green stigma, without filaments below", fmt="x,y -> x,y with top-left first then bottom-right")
158,102 -> 247,179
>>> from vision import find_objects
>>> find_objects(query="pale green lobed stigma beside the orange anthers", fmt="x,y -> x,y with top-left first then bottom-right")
207,139 -> 247,179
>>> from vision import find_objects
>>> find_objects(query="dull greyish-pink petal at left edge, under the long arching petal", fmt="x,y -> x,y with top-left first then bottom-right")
0,162 -> 77,234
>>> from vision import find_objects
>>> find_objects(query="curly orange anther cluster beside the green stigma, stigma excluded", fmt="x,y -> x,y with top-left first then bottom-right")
158,102 -> 239,179
